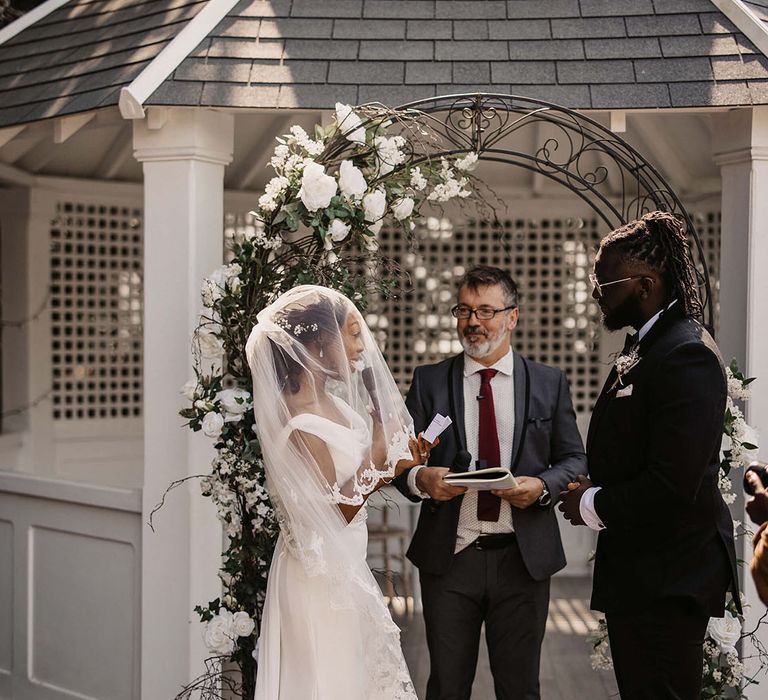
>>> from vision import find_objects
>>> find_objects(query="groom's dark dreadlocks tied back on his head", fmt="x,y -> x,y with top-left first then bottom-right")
600,211 -> 704,319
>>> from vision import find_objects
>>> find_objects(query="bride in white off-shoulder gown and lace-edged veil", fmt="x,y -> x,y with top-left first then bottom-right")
246,285 -> 431,700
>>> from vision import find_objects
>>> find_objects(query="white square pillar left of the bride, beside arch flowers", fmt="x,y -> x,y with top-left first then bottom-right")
133,108 -> 234,698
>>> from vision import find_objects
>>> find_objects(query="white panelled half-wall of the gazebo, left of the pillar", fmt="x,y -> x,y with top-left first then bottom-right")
0,472 -> 142,700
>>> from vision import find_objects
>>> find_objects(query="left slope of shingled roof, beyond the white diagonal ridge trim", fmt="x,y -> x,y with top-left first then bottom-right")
0,0 -> 208,127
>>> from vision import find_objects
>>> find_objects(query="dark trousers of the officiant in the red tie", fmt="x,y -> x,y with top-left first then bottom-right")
420,542 -> 549,700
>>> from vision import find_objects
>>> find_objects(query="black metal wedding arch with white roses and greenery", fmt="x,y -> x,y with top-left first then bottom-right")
171,93 -> 728,698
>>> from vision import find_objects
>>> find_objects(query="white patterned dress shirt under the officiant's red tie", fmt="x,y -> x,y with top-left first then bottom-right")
408,350 -> 515,552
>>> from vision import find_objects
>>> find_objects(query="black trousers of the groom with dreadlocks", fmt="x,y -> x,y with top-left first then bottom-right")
605,600 -> 709,700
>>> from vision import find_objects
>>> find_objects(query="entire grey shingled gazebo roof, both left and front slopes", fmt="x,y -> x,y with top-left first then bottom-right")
0,0 -> 768,126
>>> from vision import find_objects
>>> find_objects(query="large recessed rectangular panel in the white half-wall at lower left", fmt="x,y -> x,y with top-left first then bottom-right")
28,527 -> 138,700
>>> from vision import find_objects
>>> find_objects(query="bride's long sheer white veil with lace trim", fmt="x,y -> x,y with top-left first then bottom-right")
246,285 -> 415,699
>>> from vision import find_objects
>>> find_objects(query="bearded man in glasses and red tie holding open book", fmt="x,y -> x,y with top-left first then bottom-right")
395,266 -> 585,700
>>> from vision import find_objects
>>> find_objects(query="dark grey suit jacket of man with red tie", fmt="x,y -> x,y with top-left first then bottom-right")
395,353 -> 586,580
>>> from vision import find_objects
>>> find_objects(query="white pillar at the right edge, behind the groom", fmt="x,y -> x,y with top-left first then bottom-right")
714,107 -> 768,699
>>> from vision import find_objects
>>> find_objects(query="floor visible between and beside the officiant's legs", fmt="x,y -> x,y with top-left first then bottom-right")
395,578 -> 619,700
